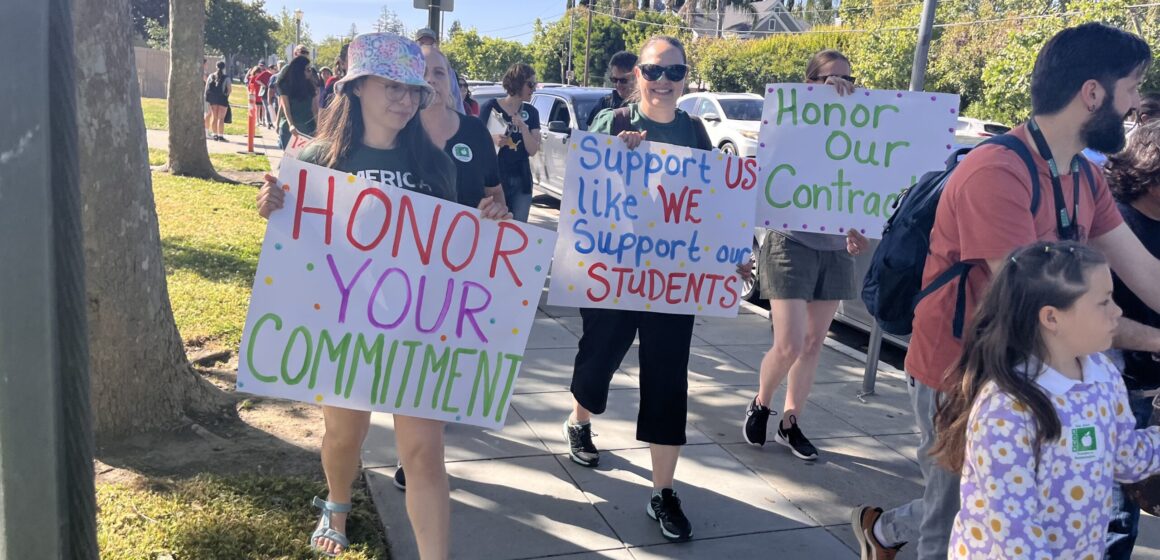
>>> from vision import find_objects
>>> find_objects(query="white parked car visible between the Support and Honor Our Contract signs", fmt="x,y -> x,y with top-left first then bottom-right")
676,93 -> 764,158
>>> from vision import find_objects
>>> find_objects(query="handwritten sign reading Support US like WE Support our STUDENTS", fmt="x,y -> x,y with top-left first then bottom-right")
548,131 -> 757,317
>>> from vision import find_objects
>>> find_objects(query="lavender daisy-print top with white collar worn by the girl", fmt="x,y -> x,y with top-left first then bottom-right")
948,354 -> 1160,560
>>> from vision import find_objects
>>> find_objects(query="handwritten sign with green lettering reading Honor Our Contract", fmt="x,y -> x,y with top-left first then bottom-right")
757,83 -> 958,238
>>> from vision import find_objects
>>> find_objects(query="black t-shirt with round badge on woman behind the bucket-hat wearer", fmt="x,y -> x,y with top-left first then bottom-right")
443,114 -> 500,208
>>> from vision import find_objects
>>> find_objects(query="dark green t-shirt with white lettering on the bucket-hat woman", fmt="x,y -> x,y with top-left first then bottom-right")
298,141 -> 456,202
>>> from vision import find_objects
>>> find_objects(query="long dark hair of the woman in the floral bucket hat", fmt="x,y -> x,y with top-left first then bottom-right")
314,77 -> 454,191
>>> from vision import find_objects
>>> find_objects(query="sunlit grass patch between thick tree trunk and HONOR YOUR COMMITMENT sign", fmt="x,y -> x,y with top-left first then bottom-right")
153,173 -> 266,349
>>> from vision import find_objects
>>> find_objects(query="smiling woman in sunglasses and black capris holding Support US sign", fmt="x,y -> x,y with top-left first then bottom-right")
563,36 -> 712,540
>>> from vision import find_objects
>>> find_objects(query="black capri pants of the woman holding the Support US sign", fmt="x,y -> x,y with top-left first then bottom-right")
572,308 -> 694,445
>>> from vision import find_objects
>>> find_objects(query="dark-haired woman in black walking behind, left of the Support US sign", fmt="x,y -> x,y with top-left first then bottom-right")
479,63 -> 539,221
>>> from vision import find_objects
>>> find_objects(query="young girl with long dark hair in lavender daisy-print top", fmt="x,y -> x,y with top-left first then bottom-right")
931,242 -> 1160,560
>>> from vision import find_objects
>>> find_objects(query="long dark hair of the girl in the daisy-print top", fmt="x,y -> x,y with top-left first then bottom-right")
930,241 -> 1108,472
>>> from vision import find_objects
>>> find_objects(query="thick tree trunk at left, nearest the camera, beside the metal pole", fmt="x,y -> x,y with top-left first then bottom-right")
73,0 -> 229,442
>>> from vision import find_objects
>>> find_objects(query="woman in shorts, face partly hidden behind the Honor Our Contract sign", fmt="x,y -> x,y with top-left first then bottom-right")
742,50 -> 869,460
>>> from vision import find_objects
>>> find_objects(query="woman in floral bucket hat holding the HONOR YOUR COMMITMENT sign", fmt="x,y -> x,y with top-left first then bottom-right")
258,34 -> 456,560
